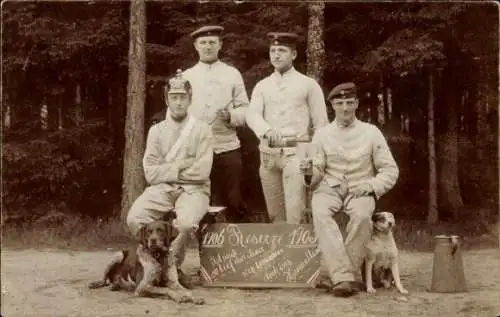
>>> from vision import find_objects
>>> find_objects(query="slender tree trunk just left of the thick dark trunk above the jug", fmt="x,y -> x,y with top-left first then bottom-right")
427,71 -> 439,224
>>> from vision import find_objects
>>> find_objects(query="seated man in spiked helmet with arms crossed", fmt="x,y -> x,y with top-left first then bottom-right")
127,70 -> 213,287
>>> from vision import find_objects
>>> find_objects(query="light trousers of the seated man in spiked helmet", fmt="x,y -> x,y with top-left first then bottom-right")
127,184 -> 210,267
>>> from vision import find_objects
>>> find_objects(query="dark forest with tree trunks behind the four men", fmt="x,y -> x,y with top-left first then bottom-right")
2,0 -> 499,247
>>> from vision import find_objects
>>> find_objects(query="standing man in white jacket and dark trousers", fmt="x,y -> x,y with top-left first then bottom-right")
184,26 -> 248,222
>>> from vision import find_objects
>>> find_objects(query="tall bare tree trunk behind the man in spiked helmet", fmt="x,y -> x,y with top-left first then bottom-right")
121,0 -> 146,220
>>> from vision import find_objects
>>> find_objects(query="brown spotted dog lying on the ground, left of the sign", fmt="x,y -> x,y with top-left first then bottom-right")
89,212 -> 204,304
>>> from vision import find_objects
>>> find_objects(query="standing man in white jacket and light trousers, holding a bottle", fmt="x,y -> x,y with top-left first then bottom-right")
247,33 -> 328,224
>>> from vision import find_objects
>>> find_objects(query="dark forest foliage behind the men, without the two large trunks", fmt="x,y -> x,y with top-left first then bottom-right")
2,1 -> 498,226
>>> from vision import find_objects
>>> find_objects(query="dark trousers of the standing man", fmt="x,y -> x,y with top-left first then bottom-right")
210,149 -> 246,223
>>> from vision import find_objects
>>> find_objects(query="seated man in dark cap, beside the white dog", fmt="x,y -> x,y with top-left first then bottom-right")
301,83 -> 399,297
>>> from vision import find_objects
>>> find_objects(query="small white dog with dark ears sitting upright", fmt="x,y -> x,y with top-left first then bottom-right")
361,212 -> 408,294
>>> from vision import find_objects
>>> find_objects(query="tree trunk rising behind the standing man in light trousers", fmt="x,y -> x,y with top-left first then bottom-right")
307,1 -> 326,86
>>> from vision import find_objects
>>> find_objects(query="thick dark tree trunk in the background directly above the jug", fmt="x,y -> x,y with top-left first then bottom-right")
438,70 -> 463,220
